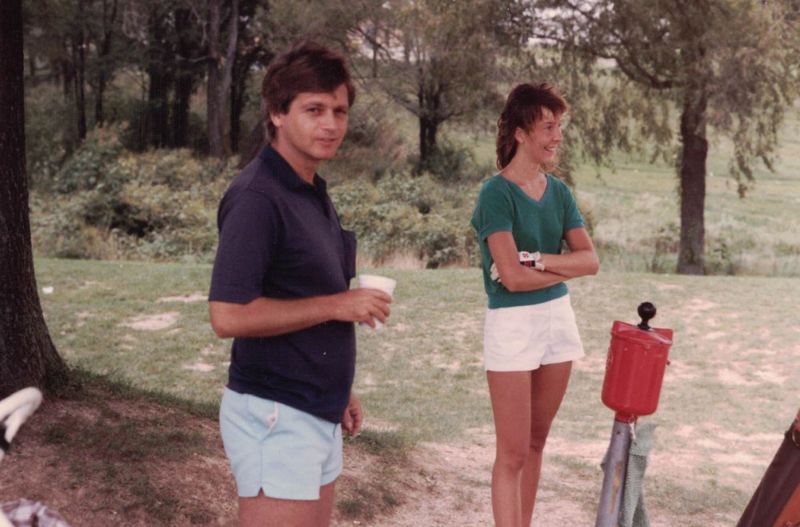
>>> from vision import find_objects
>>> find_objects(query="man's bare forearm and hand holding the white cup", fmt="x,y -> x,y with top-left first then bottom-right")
208,289 -> 392,338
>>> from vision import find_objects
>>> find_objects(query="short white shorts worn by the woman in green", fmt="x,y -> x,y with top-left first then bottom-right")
483,295 -> 585,371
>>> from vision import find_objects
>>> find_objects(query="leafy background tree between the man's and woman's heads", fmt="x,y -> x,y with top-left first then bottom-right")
359,0 -> 503,167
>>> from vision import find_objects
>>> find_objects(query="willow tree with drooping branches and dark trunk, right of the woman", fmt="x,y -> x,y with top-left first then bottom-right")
534,0 -> 798,274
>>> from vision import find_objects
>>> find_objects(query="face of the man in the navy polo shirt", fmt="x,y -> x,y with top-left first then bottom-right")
270,84 -> 350,163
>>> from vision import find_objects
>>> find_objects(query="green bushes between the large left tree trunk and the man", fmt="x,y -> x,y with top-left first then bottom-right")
32,129 -> 233,260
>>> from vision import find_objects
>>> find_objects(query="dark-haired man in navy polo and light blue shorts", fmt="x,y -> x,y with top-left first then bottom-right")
209,41 -> 391,527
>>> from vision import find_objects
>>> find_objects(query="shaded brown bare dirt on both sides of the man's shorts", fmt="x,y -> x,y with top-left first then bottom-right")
31,370 -> 413,525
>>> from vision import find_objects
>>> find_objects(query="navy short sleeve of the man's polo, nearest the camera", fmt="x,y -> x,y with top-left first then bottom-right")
209,190 -> 280,304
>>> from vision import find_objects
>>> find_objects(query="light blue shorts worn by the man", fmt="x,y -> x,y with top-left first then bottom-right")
219,388 -> 342,500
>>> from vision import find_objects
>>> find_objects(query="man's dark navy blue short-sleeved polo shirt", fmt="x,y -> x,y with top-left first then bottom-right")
209,146 -> 356,423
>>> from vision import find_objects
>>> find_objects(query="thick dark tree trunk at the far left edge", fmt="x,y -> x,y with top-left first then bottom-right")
0,0 -> 66,398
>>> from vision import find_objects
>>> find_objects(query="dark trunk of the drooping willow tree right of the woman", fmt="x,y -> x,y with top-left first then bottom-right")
677,87 -> 708,274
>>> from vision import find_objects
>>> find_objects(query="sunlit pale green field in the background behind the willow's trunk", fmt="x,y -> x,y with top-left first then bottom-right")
446,110 -> 800,276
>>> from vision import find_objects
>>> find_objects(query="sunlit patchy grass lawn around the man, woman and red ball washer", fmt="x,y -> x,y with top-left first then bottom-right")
36,259 -> 800,527
